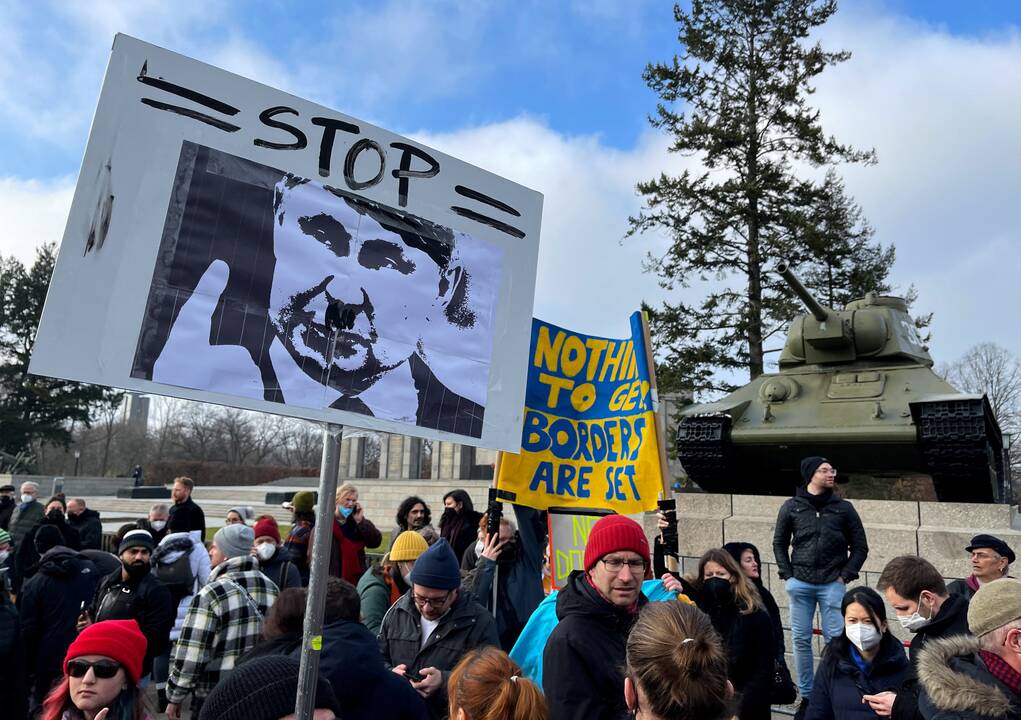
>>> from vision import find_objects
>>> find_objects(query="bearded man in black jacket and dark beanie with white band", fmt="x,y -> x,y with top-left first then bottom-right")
79,530 -> 177,676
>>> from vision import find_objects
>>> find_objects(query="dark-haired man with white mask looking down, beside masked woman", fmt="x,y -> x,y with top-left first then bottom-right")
865,555 -> 968,720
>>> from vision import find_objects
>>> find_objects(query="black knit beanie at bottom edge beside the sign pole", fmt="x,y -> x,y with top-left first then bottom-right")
198,655 -> 341,720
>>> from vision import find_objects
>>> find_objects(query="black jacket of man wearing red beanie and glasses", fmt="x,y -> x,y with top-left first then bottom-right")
542,570 -> 648,720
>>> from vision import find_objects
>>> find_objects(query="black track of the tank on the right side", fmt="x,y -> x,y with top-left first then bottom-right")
915,399 -> 1003,502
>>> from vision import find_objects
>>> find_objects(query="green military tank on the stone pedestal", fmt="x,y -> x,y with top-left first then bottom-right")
677,262 -> 1010,502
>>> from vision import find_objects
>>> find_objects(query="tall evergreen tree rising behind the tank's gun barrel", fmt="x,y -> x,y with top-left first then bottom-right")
628,0 -> 894,392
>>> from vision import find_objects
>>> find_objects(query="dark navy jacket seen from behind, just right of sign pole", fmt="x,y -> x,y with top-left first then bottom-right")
308,620 -> 428,720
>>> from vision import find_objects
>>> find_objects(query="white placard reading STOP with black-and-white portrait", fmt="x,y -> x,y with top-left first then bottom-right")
30,35 -> 542,450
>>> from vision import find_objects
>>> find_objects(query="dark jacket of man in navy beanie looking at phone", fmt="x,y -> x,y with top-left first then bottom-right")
376,590 -> 500,718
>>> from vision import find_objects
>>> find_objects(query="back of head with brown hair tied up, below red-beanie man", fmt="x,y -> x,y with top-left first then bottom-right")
624,603 -> 734,720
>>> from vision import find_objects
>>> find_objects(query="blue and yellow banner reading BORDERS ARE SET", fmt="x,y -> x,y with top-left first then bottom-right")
497,313 -> 663,514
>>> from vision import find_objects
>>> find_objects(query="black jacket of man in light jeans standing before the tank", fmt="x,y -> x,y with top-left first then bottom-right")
773,487 -> 869,584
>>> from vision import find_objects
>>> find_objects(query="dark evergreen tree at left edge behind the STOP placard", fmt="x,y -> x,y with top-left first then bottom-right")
0,245 -> 121,465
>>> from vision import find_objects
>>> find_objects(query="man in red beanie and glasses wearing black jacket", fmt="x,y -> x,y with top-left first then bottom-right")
542,515 -> 649,720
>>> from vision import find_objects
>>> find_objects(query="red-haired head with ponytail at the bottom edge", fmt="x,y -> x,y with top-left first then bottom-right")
447,646 -> 549,720
